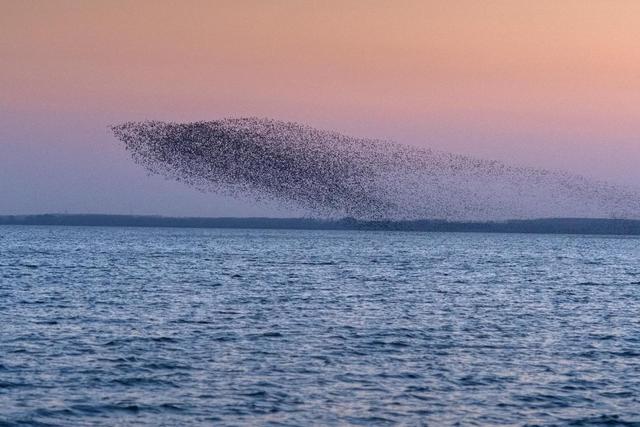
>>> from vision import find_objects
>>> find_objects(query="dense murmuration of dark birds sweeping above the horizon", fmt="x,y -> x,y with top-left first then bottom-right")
112,118 -> 640,220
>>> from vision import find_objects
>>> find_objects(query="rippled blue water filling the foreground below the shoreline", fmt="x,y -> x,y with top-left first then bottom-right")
0,227 -> 640,426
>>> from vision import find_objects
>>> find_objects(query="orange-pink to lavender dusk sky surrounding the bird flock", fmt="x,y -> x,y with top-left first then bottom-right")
0,0 -> 640,216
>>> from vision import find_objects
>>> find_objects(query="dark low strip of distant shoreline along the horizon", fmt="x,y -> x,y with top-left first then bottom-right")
0,214 -> 640,236
